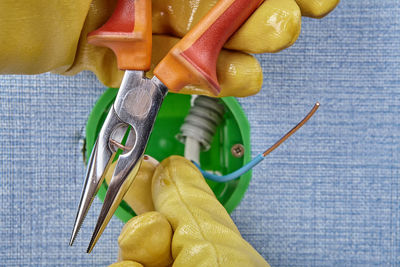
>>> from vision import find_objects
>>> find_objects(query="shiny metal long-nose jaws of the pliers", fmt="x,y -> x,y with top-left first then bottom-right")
70,71 -> 168,253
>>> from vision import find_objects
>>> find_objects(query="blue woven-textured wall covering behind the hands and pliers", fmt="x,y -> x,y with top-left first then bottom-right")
0,0 -> 400,266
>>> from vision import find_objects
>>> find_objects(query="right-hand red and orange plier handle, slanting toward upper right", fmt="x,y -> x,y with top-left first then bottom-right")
154,0 -> 264,95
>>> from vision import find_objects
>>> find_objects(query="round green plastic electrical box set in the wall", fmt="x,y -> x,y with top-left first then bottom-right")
86,88 -> 251,222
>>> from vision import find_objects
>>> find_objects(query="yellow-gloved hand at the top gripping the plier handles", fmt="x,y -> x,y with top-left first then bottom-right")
0,0 -> 339,96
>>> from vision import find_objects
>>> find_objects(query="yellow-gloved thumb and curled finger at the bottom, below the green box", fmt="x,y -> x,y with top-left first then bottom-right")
111,156 -> 269,267
